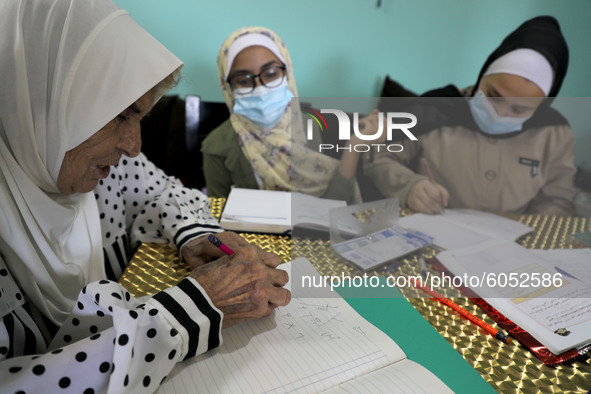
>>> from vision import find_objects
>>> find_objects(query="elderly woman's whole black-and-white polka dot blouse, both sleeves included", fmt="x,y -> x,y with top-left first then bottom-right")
0,155 -> 223,393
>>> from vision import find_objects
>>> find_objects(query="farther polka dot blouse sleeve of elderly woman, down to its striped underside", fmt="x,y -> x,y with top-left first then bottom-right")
95,154 -> 223,280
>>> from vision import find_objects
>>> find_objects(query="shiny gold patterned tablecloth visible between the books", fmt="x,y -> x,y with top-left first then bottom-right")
119,199 -> 591,393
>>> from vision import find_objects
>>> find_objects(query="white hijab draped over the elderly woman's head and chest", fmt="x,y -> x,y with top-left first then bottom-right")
0,0 -> 182,325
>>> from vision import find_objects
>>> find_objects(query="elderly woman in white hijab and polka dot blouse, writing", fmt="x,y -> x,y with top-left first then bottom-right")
0,0 -> 290,392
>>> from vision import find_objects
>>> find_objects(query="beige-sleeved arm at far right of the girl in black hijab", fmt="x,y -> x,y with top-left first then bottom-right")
527,126 -> 576,216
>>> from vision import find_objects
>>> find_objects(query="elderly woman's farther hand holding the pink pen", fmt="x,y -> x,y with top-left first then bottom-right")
181,231 -> 250,269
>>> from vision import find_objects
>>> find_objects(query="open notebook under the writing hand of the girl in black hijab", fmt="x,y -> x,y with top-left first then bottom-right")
398,209 -> 533,249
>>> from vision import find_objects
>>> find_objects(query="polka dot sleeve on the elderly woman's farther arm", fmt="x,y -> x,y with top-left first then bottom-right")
99,154 -> 223,254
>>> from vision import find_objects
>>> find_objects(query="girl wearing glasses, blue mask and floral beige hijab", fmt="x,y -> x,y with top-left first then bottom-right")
202,27 -> 372,202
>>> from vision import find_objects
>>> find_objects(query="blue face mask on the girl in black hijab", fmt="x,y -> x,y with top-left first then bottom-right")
470,90 -> 531,135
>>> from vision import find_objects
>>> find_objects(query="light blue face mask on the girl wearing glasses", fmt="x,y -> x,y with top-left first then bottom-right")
233,80 -> 293,129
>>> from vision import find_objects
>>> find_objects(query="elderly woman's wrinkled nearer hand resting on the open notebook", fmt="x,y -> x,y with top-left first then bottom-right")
190,245 -> 291,327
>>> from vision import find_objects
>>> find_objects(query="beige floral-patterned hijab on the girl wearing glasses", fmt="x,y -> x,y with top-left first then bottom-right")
218,27 -> 339,196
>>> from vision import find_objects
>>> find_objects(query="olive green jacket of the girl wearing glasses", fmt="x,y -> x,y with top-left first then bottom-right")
201,119 -> 356,202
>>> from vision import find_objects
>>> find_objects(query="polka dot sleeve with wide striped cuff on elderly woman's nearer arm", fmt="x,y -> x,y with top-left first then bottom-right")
0,278 -> 222,393
